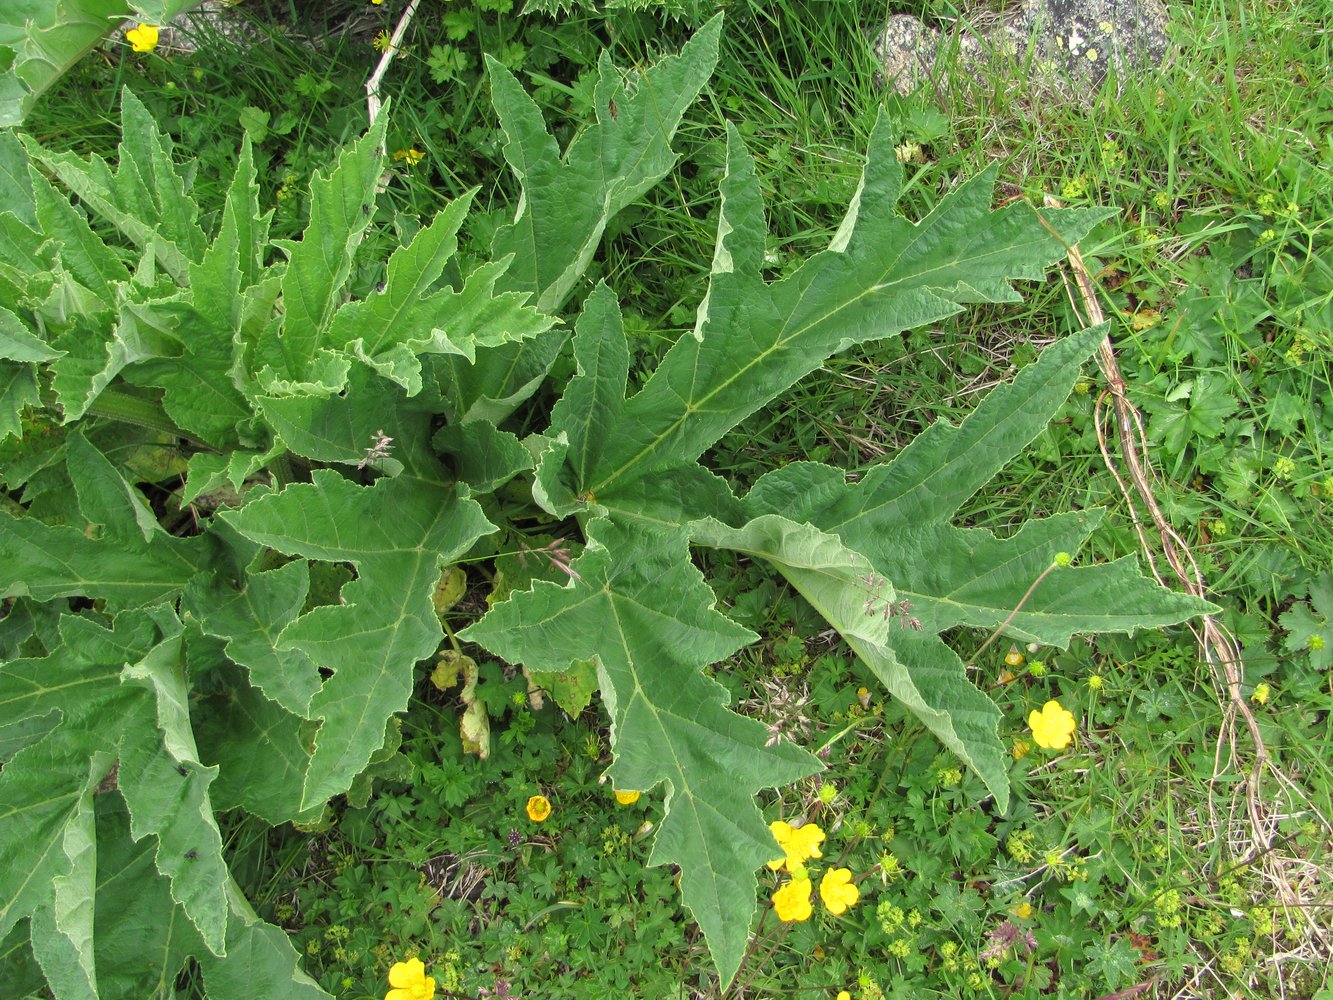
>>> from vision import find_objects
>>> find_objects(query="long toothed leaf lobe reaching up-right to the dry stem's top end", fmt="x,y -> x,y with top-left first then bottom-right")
577,119 -> 1104,513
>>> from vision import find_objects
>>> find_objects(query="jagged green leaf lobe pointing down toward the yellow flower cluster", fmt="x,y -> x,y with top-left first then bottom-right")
460,520 -> 820,983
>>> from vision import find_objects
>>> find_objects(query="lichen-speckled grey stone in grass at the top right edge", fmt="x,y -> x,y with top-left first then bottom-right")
874,0 -> 1168,95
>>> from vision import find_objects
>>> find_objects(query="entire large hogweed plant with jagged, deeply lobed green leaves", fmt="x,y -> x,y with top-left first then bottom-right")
0,19 -> 1210,997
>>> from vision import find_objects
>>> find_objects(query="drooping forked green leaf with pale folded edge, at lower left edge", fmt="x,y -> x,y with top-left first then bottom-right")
0,608 -> 229,995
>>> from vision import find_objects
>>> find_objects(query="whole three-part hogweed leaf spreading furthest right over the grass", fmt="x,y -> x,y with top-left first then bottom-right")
468,94 -> 1210,997
